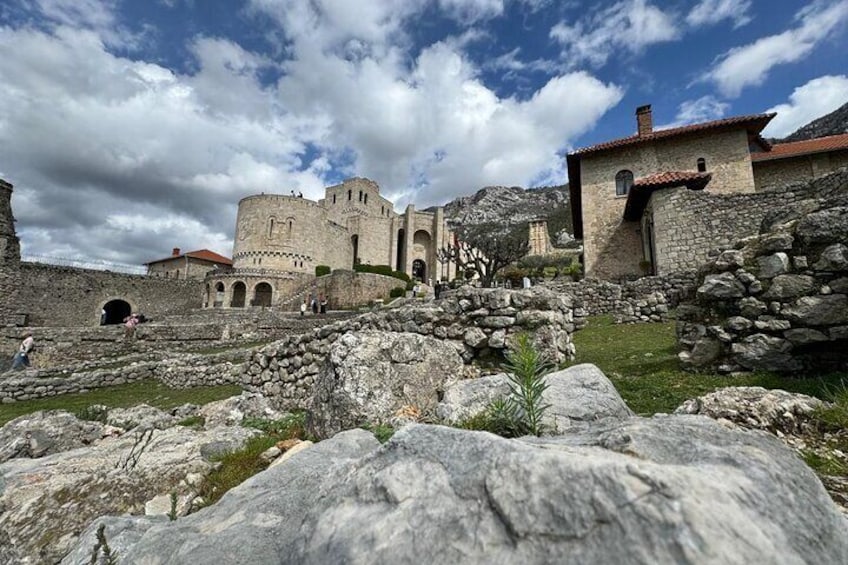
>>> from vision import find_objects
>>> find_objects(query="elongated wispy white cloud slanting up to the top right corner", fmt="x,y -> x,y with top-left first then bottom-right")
707,0 -> 848,96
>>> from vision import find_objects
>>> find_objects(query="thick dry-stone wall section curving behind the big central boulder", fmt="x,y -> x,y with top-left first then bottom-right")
241,287 -> 582,409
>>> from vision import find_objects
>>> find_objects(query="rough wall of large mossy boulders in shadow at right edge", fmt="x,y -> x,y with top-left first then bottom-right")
677,178 -> 848,374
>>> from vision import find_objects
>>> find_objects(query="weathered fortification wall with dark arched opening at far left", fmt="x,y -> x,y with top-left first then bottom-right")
10,263 -> 203,326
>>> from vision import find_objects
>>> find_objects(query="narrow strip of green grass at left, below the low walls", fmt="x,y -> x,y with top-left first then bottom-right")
0,380 -> 241,425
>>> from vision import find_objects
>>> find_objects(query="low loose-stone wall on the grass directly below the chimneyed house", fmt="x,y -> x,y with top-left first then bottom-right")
545,271 -> 697,323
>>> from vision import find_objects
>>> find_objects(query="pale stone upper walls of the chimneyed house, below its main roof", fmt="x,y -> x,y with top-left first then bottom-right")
581,130 -> 754,279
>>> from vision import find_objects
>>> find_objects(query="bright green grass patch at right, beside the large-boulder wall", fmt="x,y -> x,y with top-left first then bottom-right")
571,316 -> 848,414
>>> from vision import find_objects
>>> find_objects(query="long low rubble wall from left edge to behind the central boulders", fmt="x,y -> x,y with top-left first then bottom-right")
0,287 -> 583,408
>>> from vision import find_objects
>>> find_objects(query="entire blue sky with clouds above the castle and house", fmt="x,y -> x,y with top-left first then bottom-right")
0,0 -> 848,264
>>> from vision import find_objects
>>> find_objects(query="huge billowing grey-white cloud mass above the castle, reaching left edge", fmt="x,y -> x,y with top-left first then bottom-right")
0,0 -> 622,262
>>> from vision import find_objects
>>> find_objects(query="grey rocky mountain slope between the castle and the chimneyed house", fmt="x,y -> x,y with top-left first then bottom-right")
430,185 -> 573,243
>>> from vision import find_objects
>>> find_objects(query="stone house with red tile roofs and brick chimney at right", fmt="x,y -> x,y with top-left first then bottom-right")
566,106 -> 848,280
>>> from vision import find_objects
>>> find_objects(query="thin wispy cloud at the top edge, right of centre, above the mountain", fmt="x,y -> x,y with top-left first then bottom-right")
550,0 -> 680,67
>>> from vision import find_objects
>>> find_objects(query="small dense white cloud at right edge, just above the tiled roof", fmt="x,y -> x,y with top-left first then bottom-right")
763,75 -> 848,137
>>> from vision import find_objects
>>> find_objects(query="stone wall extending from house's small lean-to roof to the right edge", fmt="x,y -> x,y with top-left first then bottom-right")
648,169 -> 848,275
